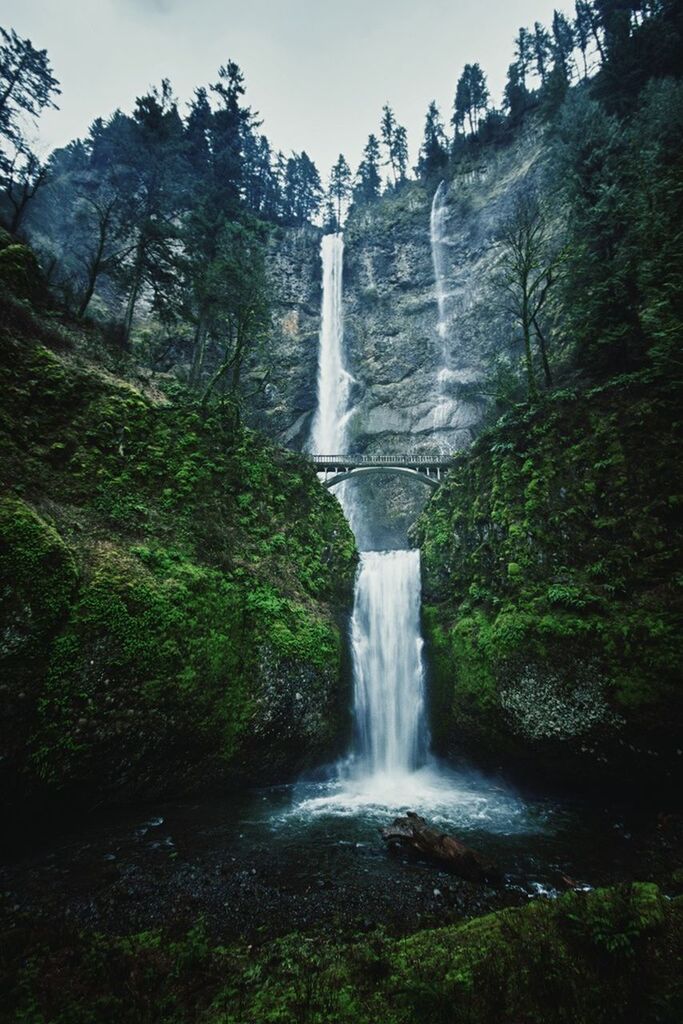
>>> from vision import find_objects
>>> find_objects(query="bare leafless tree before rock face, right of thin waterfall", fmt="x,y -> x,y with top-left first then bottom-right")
499,195 -> 560,398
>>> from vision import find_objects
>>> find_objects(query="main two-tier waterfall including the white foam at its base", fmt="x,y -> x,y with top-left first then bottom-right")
296,234 -> 520,830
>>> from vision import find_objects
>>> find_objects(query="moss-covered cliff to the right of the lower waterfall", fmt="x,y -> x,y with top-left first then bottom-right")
418,372 -> 683,780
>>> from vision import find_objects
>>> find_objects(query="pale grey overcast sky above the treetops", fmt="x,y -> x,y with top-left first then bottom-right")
1,0 -> 573,175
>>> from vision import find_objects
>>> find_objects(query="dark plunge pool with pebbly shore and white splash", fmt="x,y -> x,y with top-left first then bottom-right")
0,768 -> 683,940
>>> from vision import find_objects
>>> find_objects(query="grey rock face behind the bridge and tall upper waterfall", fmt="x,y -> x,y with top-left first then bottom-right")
249,132 -> 543,547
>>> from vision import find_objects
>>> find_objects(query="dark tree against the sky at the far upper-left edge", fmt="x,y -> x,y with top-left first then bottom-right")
0,29 -> 60,231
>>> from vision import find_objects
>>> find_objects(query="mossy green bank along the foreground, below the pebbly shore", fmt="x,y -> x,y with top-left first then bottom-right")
0,884 -> 683,1024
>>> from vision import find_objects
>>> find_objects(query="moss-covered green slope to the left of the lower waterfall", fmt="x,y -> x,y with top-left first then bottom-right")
0,302 -> 355,804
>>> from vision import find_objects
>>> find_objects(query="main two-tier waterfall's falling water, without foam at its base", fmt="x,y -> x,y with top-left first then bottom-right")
309,234 -> 427,780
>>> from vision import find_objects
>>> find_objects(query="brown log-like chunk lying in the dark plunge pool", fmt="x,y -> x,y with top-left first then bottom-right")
380,811 -> 501,882
